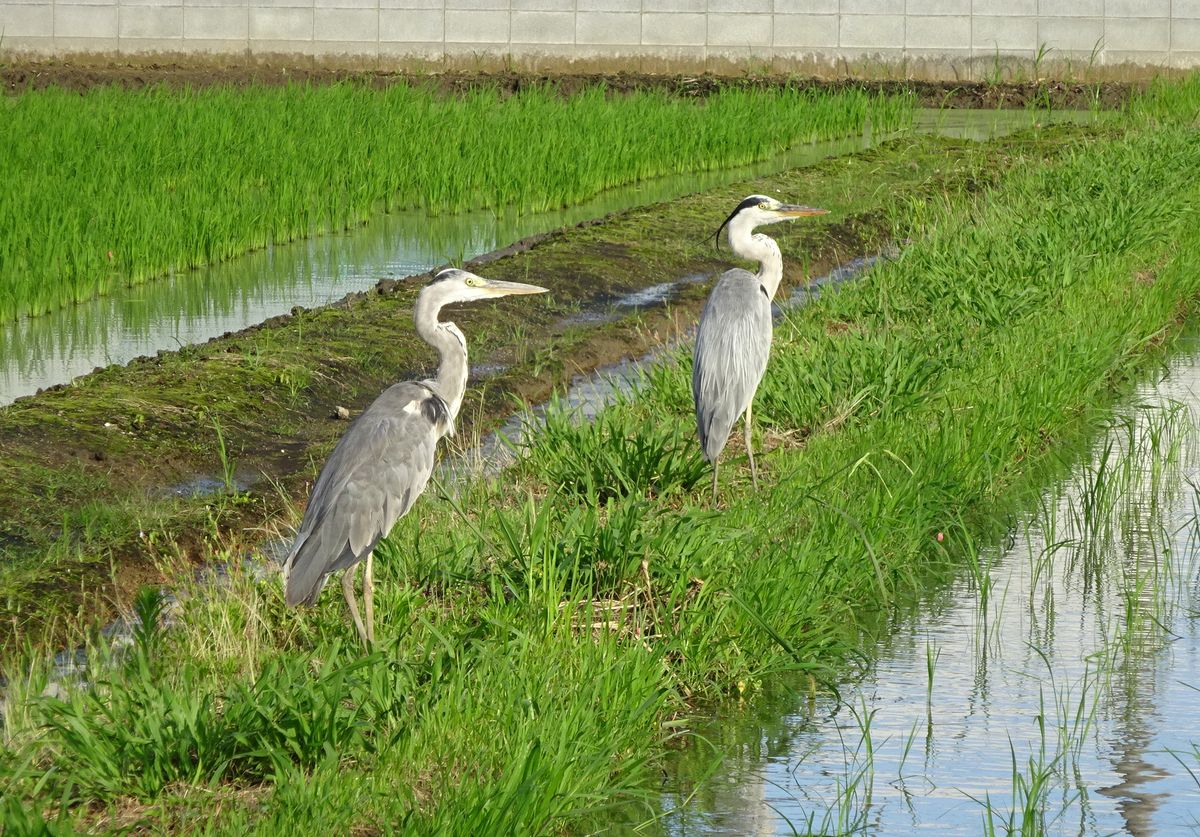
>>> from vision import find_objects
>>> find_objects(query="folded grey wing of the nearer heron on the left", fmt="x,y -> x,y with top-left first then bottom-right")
284,383 -> 451,604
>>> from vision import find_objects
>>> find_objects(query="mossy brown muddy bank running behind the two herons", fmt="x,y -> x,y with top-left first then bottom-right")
0,128 -> 1086,650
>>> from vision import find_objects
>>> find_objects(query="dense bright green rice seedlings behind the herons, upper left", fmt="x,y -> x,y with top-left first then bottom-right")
0,83 -> 912,321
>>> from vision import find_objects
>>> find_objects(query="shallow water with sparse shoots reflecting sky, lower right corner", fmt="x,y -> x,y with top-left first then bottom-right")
640,341 -> 1200,837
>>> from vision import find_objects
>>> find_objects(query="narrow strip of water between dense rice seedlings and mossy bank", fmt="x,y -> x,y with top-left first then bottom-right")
0,110 -> 1091,405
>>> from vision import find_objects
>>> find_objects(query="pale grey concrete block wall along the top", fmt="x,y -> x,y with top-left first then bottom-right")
0,0 -> 1200,78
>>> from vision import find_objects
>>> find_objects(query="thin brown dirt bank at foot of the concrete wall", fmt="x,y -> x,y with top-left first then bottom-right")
0,59 -> 1139,109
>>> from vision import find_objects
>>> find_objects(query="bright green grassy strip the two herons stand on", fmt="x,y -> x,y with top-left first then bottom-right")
0,77 -> 1200,835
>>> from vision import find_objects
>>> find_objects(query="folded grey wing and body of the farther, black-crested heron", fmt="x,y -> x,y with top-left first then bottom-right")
691,267 -> 772,462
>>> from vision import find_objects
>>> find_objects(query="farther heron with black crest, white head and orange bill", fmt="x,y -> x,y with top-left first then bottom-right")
691,194 -> 828,502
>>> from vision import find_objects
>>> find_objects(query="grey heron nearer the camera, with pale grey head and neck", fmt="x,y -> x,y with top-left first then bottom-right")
283,269 -> 546,645
